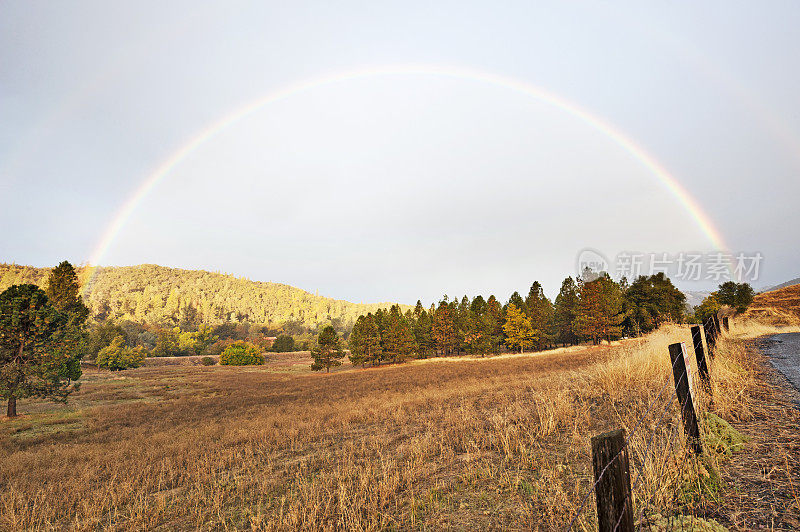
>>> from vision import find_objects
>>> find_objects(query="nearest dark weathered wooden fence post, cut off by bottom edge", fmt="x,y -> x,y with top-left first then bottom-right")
592,429 -> 633,532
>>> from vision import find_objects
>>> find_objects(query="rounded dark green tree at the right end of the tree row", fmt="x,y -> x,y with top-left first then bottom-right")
623,272 -> 686,336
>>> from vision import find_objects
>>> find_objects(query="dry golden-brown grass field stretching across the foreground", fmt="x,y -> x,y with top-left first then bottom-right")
0,320 -> 800,530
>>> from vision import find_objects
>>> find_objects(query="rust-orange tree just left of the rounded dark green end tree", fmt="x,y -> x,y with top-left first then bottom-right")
575,272 -> 624,344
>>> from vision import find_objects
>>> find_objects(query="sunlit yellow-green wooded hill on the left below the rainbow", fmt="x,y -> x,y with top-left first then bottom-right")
0,264 -> 400,328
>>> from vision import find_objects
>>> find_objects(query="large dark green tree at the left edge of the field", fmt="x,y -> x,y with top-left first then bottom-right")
0,284 -> 82,417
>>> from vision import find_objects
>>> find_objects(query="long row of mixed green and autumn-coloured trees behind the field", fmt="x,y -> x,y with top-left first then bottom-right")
348,272 -> 686,365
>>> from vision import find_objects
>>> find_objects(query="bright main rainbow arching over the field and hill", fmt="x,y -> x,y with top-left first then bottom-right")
84,65 -> 727,286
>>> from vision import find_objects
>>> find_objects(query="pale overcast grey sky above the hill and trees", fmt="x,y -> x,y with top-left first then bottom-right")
0,0 -> 800,303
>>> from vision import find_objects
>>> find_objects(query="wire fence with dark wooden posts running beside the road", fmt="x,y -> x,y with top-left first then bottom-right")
565,317 -> 729,532
